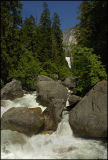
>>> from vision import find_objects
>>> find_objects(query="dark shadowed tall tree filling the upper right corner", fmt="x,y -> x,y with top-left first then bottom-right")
76,0 -> 108,71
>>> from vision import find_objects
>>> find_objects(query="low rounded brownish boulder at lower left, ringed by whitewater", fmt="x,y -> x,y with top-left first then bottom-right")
1,107 -> 44,136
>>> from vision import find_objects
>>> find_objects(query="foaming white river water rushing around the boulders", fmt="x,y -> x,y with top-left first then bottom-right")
1,92 -> 107,159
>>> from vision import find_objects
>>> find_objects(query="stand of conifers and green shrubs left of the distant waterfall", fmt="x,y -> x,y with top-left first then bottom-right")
1,1 -> 71,89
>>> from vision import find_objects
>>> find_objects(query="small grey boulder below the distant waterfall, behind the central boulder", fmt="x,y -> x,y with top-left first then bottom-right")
62,77 -> 76,89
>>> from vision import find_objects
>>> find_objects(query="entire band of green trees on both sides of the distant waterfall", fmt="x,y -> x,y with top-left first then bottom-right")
0,0 -> 108,95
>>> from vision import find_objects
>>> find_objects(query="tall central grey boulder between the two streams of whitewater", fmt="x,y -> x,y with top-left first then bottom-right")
37,81 -> 67,130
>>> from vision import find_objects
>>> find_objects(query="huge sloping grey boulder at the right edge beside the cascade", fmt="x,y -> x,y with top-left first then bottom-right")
69,80 -> 107,138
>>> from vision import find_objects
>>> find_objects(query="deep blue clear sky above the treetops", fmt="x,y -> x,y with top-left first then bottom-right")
21,0 -> 81,31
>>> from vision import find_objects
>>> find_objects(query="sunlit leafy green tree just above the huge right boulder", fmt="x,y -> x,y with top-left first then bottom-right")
72,45 -> 107,96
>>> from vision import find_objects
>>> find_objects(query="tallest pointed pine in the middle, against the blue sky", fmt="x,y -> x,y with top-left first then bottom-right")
38,2 -> 52,62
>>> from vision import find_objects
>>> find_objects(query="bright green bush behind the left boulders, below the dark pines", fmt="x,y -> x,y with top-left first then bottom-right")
9,50 -> 42,89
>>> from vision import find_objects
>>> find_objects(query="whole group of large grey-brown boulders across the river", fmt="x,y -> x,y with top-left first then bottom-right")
1,75 -> 107,137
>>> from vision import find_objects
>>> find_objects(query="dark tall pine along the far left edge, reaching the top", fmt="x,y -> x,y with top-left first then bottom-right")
1,1 -> 22,83
